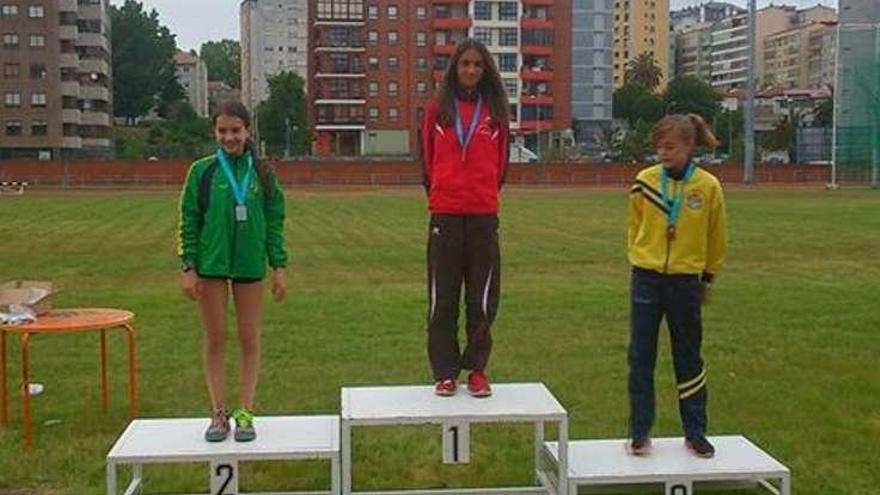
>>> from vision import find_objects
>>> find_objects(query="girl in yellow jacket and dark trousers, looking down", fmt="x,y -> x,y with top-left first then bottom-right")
627,114 -> 727,457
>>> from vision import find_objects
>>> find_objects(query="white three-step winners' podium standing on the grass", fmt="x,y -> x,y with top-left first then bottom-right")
107,383 -> 791,495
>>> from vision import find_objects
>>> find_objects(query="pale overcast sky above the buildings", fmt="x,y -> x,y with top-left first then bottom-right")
122,0 -> 837,50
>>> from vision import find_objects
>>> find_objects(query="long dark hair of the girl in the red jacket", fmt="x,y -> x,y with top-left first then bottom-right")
437,38 -> 510,126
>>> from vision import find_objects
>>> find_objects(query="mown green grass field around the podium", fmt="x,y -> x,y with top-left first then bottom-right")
0,189 -> 880,495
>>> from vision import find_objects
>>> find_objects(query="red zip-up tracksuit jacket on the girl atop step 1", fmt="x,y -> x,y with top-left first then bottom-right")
422,98 -> 510,215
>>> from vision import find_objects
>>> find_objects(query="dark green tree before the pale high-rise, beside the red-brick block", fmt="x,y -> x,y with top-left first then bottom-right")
257,71 -> 312,155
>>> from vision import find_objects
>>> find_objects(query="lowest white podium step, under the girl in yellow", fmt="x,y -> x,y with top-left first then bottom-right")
545,435 -> 789,494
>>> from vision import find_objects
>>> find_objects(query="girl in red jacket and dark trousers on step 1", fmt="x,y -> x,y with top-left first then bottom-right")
422,39 -> 509,397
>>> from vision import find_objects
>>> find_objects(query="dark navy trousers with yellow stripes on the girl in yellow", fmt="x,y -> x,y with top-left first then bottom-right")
628,267 -> 708,438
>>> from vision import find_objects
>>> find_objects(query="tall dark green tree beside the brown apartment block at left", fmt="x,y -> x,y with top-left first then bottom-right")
110,0 -> 177,123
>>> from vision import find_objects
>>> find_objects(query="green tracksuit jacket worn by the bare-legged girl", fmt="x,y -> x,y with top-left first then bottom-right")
177,155 -> 287,279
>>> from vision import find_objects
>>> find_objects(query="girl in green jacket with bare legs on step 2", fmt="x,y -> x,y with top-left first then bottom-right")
178,102 -> 287,442
